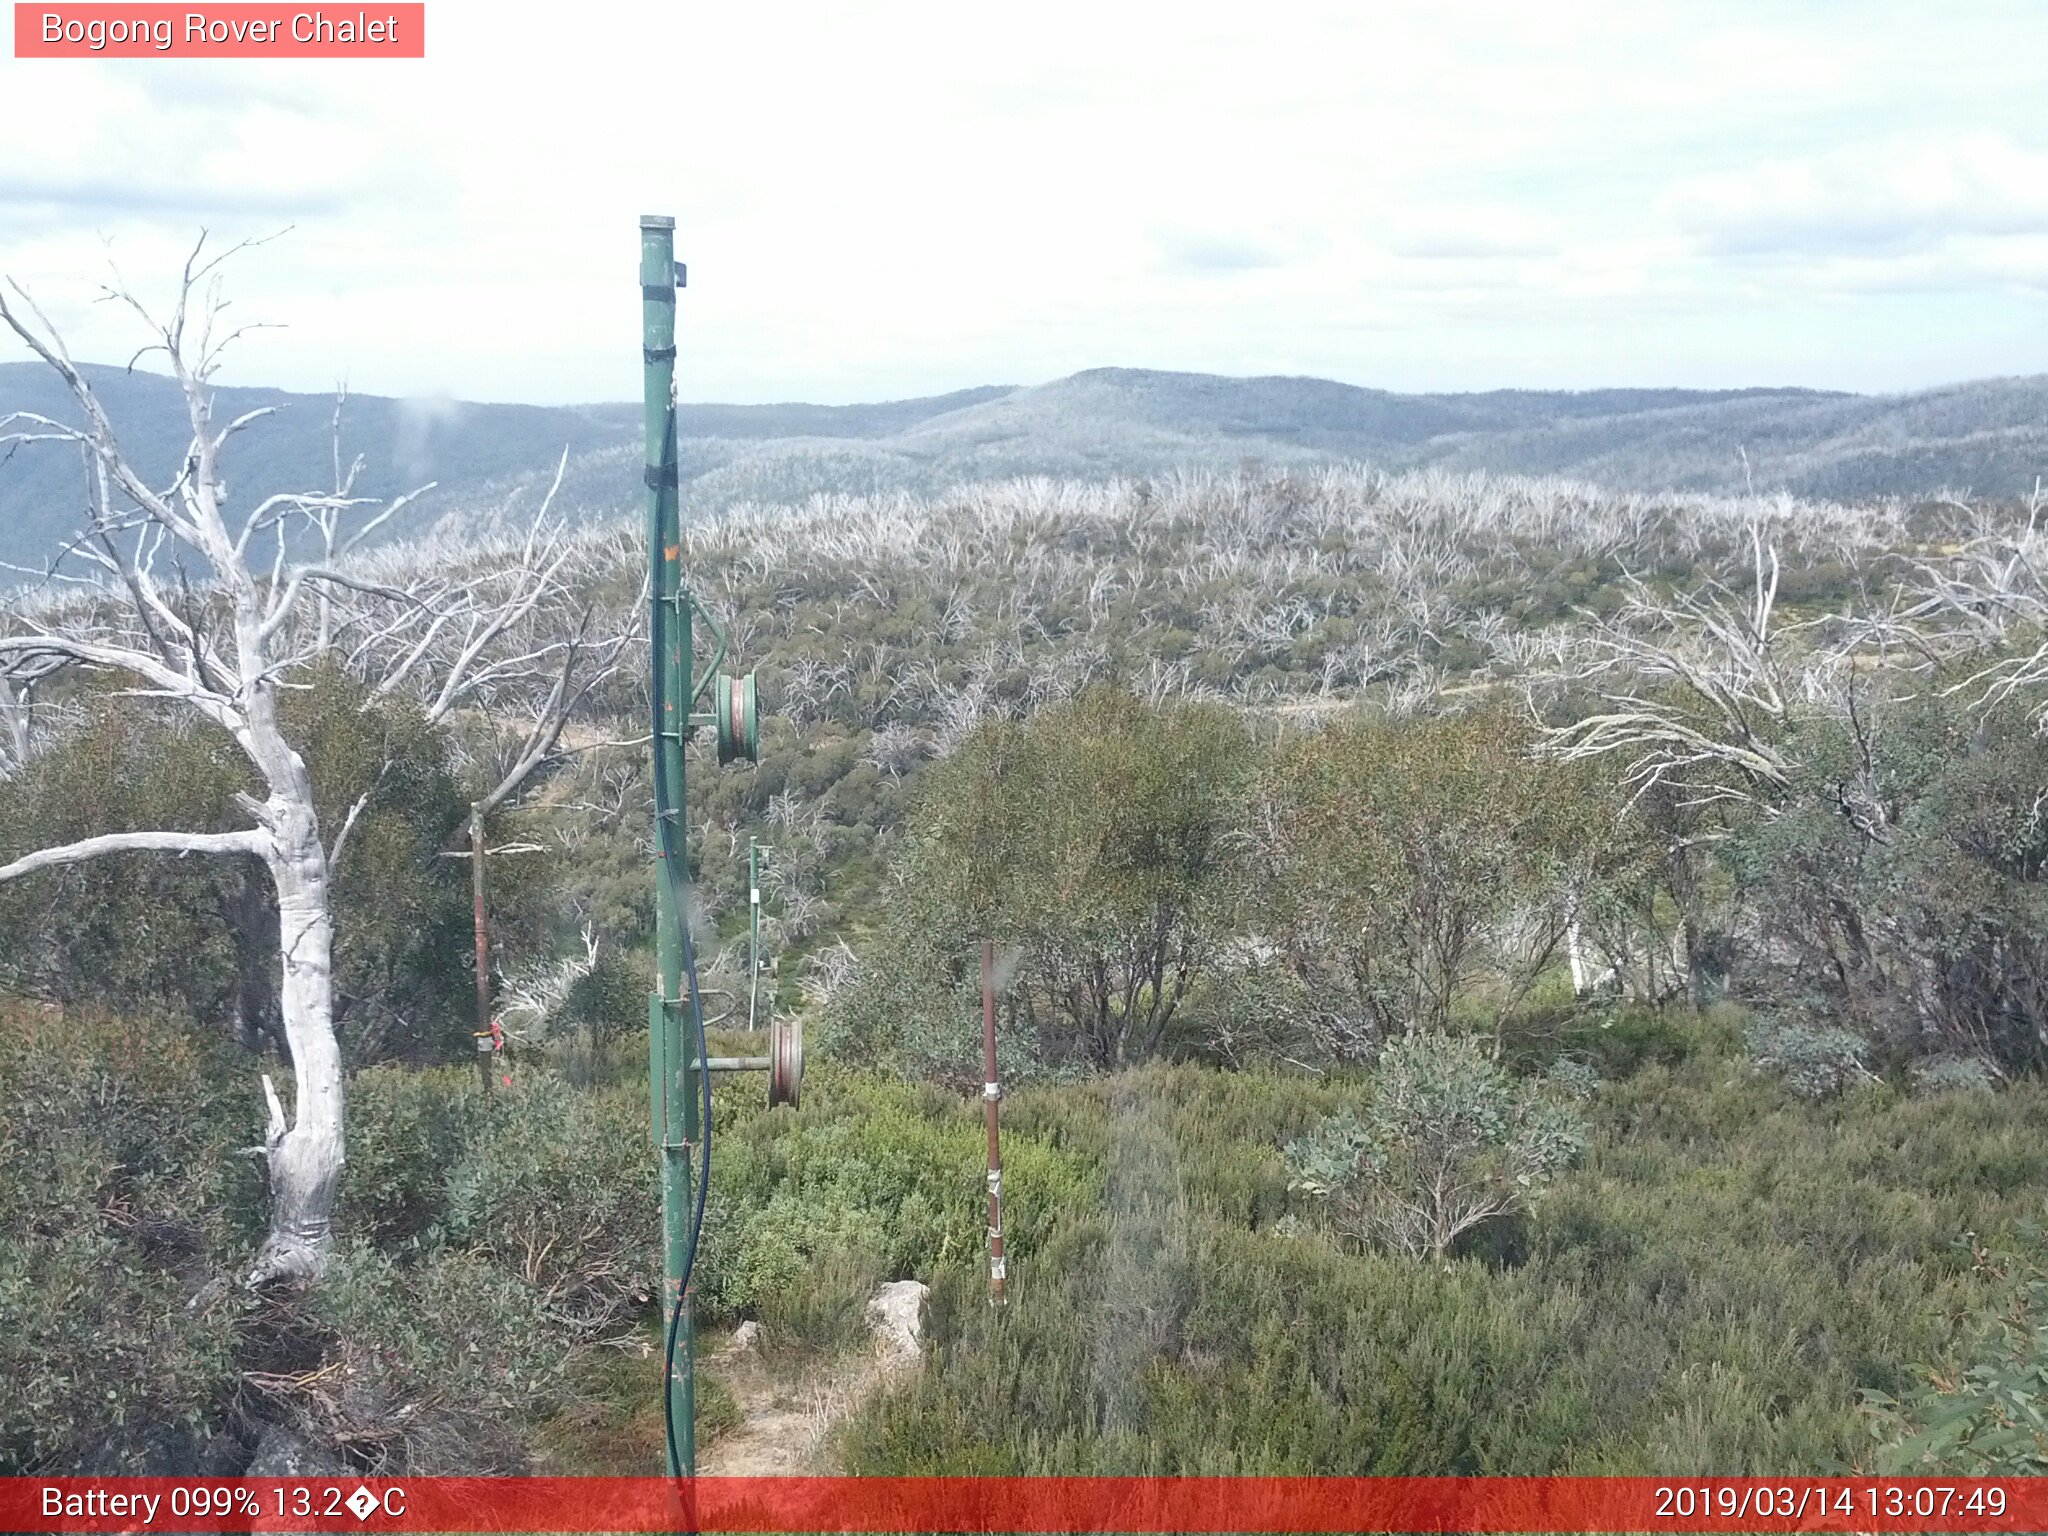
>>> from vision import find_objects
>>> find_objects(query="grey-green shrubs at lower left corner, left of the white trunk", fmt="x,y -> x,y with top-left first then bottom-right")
0,1001 -> 258,1473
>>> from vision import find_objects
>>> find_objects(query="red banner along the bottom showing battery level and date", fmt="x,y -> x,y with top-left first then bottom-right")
0,1477 -> 2048,1536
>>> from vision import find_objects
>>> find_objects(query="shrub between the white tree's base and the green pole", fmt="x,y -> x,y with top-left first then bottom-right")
270,1065 -> 662,1473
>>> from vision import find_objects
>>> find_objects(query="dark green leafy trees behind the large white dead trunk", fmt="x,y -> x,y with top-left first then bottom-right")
0,668 -> 491,1061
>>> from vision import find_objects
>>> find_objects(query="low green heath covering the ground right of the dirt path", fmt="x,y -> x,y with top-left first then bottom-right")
846,1049 -> 2048,1475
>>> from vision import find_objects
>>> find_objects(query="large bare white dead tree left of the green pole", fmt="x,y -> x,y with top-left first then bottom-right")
0,236 -> 589,1284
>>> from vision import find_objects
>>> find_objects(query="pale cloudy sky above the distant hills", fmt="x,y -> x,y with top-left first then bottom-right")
0,0 -> 2048,403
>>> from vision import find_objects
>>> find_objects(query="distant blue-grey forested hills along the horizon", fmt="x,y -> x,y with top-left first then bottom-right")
0,362 -> 2048,565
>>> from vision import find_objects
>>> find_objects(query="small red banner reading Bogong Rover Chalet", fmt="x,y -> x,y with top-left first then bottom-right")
14,0 -> 426,59
